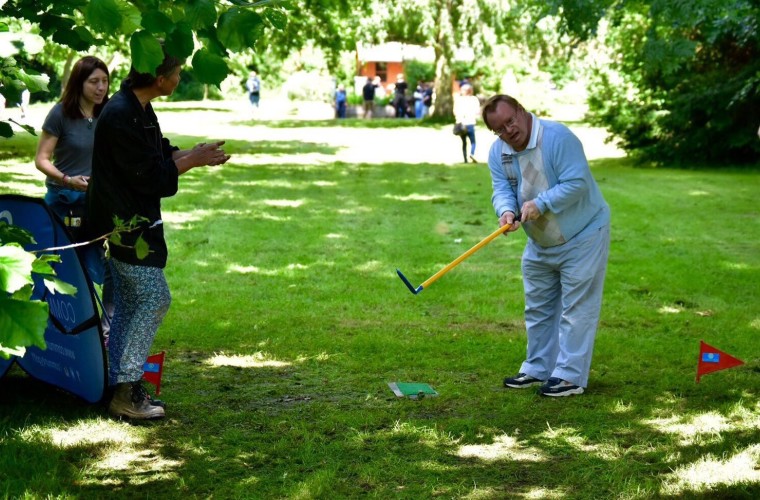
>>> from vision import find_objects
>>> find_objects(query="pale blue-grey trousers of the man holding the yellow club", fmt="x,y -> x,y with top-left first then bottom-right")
520,225 -> 610,387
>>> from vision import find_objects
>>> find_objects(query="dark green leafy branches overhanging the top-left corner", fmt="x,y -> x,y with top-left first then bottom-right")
0,0 -> 286,137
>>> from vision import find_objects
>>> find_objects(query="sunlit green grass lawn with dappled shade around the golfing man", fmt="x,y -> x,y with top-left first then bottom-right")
0,104 -> 760,499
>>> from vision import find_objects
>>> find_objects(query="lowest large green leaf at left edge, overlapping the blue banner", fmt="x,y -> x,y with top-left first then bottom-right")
0,297 -> 48,352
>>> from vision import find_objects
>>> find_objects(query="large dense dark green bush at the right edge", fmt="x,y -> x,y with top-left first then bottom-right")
589,0 -> 760,166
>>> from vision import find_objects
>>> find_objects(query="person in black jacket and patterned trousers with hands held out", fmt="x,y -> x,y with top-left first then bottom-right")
87,50 -> 230,419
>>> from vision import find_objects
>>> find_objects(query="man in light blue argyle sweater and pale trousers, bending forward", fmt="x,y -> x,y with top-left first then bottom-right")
482,95 -> 610,396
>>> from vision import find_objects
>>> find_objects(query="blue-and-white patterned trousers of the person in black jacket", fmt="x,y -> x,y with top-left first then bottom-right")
108,258 -> 171,385
